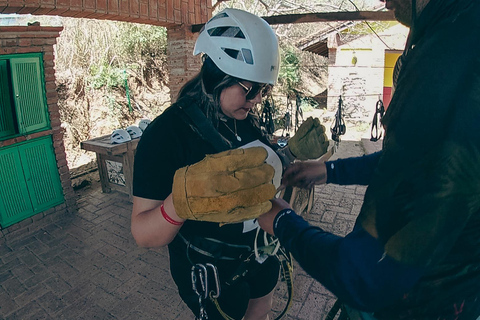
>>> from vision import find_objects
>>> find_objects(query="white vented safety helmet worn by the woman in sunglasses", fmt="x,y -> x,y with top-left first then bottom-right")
193,8 -> 280,85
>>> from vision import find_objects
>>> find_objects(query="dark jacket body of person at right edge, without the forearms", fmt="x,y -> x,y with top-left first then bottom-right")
358,0 -> 480,320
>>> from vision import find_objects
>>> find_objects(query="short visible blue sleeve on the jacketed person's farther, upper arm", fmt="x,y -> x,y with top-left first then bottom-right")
325,151 -> 382,185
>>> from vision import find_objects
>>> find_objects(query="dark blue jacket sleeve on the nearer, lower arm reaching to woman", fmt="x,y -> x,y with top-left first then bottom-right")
274,209 -> 422,311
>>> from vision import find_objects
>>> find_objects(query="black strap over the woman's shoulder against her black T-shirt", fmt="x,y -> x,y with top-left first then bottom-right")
175,99 -> 232,152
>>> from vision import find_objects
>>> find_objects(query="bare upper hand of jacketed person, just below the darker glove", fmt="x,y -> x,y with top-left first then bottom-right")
282,160 -> 327,189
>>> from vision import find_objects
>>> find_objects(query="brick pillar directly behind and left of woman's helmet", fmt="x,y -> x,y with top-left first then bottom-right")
167,25 -> 201,102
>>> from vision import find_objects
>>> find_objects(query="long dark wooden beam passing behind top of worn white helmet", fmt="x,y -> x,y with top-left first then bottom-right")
192,11 -> 395,33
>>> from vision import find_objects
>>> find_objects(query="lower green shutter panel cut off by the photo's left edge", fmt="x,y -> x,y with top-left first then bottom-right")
0,147 -> 33,227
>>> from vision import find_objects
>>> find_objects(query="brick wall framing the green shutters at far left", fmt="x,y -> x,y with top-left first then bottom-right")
0,26 -> 76,234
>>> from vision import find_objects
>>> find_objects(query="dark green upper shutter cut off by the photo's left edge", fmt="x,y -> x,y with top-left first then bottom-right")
0,60 -> 15,138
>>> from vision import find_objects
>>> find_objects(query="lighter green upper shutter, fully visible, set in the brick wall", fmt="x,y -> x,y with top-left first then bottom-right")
10,57 -> 48,133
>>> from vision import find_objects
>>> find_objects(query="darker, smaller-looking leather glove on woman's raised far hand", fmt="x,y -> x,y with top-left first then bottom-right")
288,117 -> 328,160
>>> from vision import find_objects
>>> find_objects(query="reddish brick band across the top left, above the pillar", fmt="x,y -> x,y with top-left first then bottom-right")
0,0 -> 212,27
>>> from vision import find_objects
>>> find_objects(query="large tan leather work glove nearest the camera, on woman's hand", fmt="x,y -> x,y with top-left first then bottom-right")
173,147 -> 276,223
